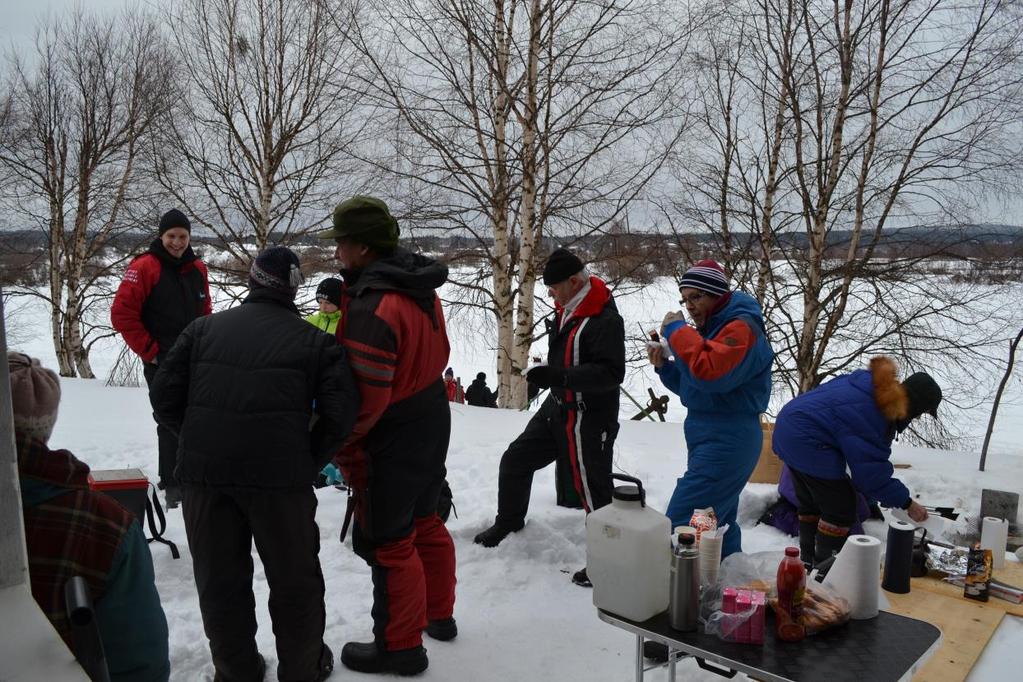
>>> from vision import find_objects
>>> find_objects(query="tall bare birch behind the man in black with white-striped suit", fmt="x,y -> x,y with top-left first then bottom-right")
339,0 -> 691,407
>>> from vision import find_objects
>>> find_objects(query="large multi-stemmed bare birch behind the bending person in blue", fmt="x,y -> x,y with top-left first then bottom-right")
670,0 -> 1023,423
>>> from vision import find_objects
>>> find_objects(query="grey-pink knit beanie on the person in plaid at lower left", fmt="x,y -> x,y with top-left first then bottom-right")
7,351 -> 60,443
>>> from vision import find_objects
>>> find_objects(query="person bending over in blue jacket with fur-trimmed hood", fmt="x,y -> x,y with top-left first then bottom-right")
772,356 -> 941,564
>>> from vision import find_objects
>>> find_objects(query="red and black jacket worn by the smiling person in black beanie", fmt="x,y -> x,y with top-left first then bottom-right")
110,239 -> 213,362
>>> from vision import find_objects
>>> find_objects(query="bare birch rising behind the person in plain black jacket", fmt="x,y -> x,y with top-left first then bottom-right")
153,0 -> 365,290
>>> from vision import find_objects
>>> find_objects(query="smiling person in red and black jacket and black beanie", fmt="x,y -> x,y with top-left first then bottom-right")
110,209 -> 213,509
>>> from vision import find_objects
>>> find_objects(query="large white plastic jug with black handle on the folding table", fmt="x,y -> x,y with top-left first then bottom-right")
586,473 -> 671,622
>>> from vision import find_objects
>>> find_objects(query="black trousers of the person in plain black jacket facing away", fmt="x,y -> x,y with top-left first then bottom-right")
183,486 -> 326,681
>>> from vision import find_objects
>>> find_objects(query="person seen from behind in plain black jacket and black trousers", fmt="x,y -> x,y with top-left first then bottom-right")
150,246 -> 359,680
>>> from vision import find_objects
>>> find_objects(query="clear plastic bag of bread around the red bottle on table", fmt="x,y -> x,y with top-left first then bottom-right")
700,551 -> 852,639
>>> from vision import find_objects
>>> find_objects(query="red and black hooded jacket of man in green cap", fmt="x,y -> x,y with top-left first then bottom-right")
337,248 -> 450,487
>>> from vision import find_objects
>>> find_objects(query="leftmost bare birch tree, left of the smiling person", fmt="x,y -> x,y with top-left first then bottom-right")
0,11 -> 172,378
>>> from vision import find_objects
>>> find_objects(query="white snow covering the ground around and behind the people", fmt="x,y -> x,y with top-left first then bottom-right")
7,274 -> 1023,682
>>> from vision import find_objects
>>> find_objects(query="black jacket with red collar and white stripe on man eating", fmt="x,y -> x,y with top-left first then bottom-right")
544,277 -> 625,418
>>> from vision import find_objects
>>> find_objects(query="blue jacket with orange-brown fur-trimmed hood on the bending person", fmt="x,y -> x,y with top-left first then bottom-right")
771,357 -> 909,507
